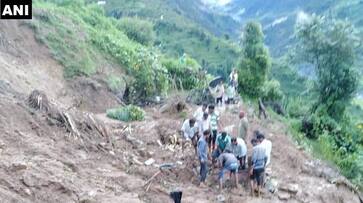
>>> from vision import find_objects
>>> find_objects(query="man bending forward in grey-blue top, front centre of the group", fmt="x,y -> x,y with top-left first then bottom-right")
218,149 -> 238,190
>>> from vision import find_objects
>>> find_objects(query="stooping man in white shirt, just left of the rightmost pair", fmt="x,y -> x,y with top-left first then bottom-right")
227,137 -> 247,170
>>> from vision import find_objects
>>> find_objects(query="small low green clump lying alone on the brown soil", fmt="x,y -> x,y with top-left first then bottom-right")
107,105 -> 145,122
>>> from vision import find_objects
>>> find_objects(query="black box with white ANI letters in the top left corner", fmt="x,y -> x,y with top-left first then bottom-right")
0,0 -> 32,19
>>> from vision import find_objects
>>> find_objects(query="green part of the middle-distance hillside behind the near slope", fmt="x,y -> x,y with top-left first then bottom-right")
105,0 -> 238,78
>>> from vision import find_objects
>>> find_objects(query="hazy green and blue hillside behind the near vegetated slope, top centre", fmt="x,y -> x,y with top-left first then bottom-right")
105,0 -> 238,76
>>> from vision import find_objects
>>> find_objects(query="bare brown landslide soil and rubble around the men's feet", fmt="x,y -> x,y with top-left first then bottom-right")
0,21 -> 360,203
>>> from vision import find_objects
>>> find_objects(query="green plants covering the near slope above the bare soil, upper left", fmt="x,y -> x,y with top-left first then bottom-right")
28,0 -> 208,103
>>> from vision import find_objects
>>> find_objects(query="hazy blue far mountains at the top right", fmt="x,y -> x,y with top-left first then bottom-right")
201,0 -> 363,56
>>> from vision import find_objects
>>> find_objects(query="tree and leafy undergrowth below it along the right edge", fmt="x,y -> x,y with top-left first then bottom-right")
290,16 -> 363,187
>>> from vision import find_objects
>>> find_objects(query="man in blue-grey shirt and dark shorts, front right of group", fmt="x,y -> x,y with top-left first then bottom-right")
250,139 -> 266,196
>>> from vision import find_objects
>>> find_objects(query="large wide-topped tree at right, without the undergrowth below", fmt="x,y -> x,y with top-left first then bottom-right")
296,15 -> 359,121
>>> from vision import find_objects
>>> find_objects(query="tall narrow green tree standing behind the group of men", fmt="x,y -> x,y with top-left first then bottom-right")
238,22 -> 271,98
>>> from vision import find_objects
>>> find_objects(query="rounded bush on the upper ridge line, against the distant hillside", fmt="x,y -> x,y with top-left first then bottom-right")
117,17 -> 155,46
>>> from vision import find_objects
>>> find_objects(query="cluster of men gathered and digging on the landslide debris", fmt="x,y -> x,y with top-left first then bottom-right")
181,104 -> 272,195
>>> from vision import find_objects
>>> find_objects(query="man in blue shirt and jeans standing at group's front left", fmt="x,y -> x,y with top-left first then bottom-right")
197,130 -> 210,187
